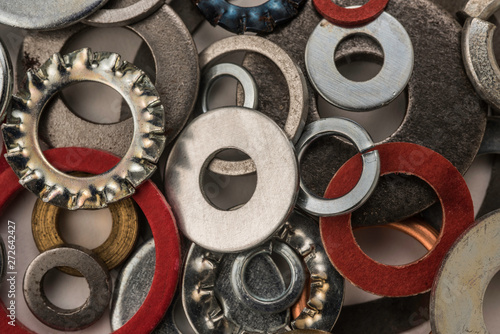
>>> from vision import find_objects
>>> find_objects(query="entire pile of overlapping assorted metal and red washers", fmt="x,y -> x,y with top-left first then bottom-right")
0,0 -> 500,334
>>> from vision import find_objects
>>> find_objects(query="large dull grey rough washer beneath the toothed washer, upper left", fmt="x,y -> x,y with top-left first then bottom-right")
17,5 -> 199,156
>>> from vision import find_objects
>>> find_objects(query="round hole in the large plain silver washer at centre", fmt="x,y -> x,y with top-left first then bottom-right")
200,149 -> 257,211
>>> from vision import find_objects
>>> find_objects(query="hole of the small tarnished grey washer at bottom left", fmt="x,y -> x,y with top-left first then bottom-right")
42,268 -> 90,310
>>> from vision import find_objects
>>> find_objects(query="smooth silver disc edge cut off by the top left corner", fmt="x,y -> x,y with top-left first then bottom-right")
0,0 -> 107,30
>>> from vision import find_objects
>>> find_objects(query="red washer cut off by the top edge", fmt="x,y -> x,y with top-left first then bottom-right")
313,0 -> 389,27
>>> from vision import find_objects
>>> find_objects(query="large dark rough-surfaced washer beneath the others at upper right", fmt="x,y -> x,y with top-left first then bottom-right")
238,0 -> 487,226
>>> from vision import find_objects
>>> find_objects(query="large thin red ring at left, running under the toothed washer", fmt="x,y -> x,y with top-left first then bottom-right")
0,148 -> 181,334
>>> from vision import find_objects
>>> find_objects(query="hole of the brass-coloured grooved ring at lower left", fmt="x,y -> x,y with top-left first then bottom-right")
57,209 -> 112,249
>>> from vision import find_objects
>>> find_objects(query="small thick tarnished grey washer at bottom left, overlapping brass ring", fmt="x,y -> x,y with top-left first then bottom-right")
23,245 -> 111,331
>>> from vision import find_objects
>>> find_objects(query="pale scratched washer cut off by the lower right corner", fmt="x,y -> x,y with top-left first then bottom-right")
430,211 -> 500,334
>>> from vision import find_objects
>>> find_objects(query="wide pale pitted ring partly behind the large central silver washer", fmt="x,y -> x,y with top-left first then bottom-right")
200,36 -> 309,175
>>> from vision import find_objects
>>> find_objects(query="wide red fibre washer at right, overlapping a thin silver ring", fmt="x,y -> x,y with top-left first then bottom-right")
320,143 -> 474,297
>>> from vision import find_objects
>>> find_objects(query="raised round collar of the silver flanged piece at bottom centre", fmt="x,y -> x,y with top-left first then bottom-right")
231,242 -> 306,313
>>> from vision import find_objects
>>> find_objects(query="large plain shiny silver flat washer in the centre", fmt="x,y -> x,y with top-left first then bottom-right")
165,107 -> 299,252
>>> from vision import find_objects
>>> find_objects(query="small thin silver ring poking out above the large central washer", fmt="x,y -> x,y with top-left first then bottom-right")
200,63 -> 259,113
